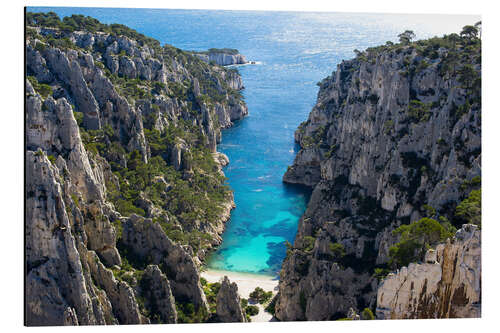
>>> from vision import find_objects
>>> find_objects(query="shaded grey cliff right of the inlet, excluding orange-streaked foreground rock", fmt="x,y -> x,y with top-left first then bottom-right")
276,34 -> 481,320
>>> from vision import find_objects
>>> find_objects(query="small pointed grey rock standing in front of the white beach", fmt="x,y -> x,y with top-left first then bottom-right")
216,276 -> 246,323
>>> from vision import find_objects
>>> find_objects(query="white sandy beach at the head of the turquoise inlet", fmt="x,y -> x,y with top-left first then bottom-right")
201,269 -> 279,322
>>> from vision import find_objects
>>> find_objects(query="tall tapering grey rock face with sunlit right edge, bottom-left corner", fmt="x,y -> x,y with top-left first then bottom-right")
25,150 -> 104,326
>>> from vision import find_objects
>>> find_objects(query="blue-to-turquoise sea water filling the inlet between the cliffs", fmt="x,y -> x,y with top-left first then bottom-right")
29,7 -> 479,274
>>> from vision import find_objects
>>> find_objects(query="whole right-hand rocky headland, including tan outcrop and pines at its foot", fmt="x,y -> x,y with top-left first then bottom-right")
276,26 -> 481,320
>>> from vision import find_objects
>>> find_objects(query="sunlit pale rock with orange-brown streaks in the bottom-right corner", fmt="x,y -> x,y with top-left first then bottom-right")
377,224 -> 481,319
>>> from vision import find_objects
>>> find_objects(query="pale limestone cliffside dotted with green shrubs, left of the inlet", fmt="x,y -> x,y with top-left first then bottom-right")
25,13 -> 247,325
